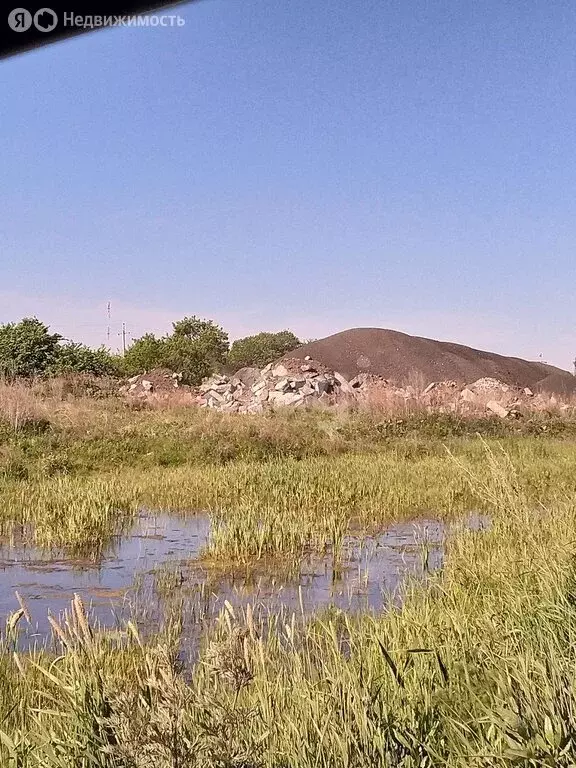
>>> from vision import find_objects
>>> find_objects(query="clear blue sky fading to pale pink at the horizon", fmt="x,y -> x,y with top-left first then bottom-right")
0,0 -> 576,368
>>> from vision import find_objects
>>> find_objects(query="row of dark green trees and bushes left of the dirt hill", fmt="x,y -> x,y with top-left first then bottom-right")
0,316 -> 302,384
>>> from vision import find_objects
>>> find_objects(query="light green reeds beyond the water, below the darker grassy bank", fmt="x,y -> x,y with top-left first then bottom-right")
0,426 -> 576,561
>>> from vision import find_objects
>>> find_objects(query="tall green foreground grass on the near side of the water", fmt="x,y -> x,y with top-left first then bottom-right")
0,450 -> 576,768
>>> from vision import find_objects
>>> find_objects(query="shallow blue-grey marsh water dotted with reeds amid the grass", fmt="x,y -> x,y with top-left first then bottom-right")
0,512 -> 487,644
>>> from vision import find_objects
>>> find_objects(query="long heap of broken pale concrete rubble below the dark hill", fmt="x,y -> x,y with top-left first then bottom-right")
120,357 -> 571,418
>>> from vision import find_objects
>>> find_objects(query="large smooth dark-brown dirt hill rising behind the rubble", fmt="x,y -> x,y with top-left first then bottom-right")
287,328 -> 576,394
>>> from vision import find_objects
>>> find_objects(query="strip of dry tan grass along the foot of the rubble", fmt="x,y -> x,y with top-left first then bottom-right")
0,380 -> 576,434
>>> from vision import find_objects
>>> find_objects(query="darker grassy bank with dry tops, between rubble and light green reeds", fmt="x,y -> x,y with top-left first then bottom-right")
0,393 -> 576,479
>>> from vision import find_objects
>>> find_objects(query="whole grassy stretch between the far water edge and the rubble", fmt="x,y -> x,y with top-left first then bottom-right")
0,386 -> 576,559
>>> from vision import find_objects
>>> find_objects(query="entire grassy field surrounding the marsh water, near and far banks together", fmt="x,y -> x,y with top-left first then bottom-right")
0,384 -> 576,768
